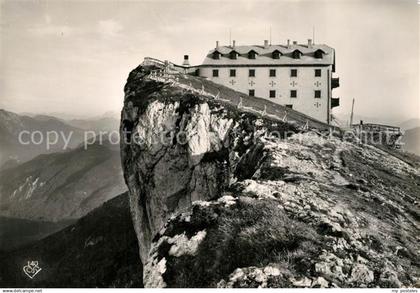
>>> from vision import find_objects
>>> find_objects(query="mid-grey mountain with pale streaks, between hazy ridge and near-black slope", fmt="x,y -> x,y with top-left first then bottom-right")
0,140 -> 126,221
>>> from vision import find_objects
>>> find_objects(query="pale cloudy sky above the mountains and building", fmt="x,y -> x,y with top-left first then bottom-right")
0,0 -> 420,122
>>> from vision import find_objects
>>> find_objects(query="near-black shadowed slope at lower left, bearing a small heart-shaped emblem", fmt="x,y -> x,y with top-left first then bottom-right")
0,193 -> 143,288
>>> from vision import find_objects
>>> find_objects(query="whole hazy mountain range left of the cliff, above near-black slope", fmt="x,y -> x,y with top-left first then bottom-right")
0,110 -> 126,249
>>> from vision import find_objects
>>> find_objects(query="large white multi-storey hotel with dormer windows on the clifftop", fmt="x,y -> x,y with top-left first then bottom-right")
198,40 -> 339,123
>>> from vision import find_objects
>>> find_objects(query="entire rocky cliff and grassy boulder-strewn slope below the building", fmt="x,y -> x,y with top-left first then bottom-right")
121,66 -> 420,287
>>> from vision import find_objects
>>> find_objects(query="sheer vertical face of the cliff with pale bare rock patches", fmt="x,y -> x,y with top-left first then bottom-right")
121,67 -> 296,261
